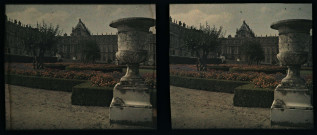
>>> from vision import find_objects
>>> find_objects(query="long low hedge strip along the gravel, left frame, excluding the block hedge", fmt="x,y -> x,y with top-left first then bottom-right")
5,74 -> 85,92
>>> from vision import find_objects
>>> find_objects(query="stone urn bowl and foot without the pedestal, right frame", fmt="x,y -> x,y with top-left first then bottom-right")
271,19 -> 312,87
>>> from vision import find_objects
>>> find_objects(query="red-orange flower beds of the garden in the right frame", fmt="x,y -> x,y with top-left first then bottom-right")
170,64 -> 312,88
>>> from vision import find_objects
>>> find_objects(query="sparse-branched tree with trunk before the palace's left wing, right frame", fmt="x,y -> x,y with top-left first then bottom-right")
184,23 -> 224,71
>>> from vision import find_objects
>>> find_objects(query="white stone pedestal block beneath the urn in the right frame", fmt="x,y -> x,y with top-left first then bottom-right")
271,85 -> 314,127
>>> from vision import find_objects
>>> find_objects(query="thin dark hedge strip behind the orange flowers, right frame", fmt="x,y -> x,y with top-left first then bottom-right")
229,68 -> 287,74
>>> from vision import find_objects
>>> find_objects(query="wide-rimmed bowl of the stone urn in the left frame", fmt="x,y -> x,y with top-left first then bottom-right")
110,17 -> 155,64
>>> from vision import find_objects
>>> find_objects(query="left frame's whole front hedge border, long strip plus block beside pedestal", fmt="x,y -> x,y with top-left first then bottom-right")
5,74 -> 157,108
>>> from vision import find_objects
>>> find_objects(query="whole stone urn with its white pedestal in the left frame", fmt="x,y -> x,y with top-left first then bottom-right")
110,17 -> 155,126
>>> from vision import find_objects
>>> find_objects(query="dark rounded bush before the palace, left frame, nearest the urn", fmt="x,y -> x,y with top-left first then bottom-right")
79,39 -> 100,63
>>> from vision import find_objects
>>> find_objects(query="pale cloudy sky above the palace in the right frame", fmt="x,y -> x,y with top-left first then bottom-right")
170,3 -> 312,36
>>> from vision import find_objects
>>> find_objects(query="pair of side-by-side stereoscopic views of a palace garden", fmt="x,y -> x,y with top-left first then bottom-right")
4,3 -> 314,131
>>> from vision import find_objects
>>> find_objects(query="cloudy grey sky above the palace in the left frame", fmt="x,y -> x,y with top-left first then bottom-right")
6,4 -> 155,35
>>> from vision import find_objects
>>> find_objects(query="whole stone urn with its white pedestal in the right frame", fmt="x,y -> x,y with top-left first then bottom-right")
271,19 -> 314,127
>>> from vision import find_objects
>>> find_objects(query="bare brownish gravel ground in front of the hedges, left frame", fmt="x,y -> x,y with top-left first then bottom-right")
5,84 -> 153,130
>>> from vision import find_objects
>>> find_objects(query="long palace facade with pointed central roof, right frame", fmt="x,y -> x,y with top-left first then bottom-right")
169,18 -> 312,64
